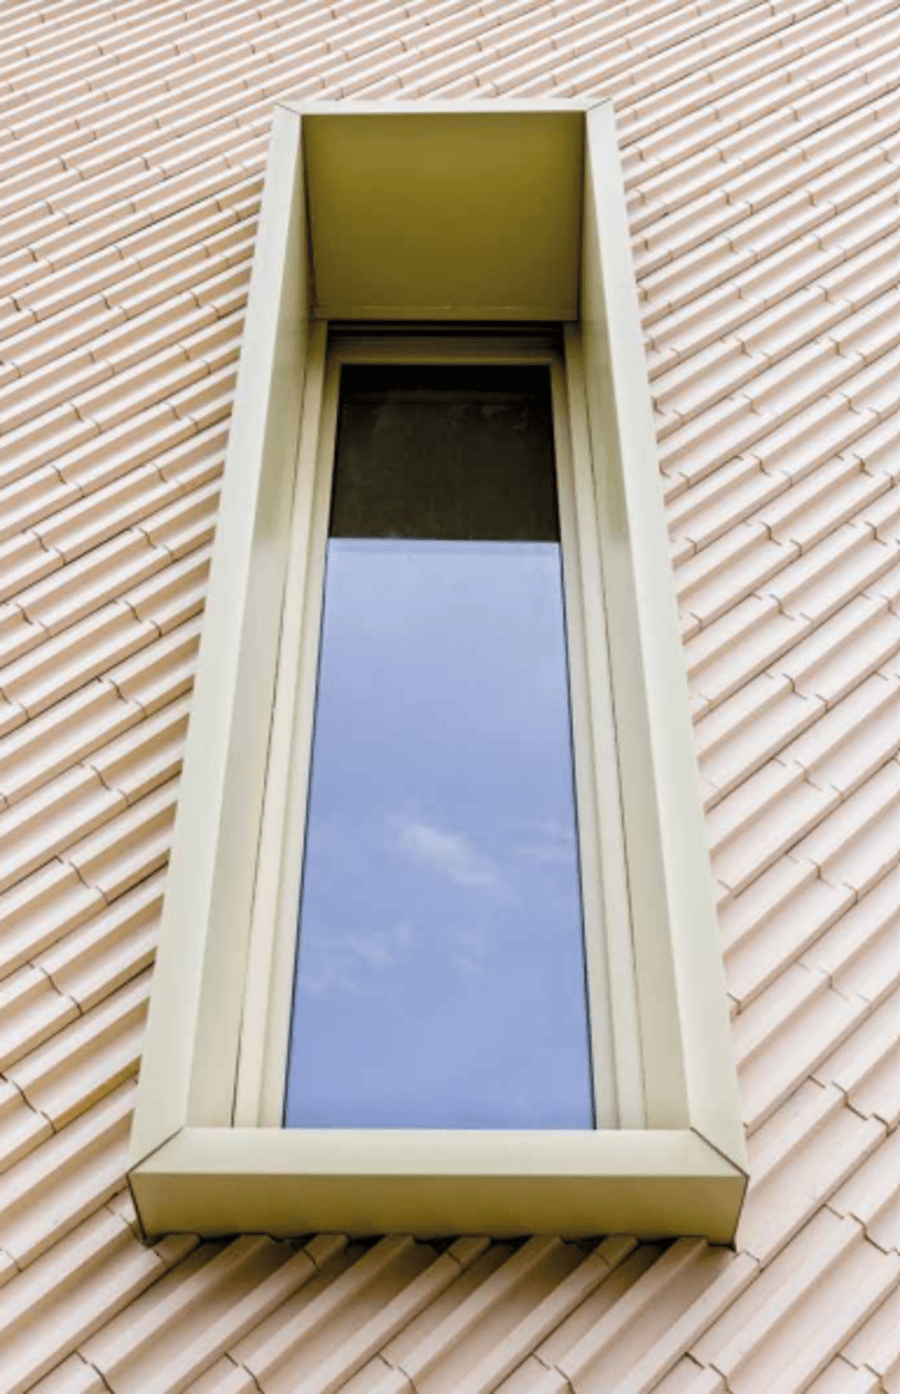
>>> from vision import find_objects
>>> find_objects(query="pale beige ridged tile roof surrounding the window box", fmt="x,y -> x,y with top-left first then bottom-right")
0,0 -> 900,1394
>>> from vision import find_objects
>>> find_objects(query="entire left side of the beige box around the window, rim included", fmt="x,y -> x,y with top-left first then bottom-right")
131,103 -> 309,1158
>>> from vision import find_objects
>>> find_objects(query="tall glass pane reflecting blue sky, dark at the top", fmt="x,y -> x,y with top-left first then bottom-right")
284,367 -> 593,1128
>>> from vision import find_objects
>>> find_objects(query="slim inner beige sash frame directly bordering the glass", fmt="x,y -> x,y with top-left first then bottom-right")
234,326 -> 644,1150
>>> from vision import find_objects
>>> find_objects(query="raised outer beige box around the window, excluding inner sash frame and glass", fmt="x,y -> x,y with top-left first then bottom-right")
130,99 -> 747,1242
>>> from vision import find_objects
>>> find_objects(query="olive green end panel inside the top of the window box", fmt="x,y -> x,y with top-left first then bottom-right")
304,103 -> 584,321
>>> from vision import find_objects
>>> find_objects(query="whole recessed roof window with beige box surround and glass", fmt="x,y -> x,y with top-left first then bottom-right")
130,100 -> 747,1242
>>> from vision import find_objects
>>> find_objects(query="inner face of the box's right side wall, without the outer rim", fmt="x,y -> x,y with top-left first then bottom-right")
581,107 -> 690,1128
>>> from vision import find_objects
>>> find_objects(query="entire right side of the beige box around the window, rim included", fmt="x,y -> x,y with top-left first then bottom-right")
582,106 -> 745,1167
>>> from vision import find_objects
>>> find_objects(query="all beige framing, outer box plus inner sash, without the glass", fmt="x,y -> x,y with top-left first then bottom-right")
130,102 -> 747,1242
